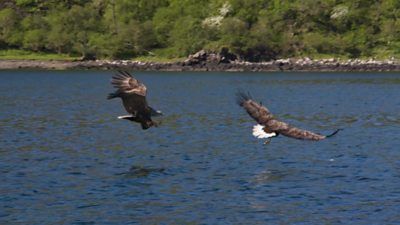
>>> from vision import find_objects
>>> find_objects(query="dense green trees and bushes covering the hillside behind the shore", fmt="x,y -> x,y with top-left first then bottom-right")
0,0 -> 400,61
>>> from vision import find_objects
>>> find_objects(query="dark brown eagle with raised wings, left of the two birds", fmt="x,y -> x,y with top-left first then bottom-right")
107,71 -> 162,130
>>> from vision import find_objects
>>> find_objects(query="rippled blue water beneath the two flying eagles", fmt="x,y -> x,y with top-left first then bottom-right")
0,71 -> 400,224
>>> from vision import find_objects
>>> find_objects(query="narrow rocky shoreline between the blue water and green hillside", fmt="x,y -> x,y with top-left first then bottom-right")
0,58 -> 400,72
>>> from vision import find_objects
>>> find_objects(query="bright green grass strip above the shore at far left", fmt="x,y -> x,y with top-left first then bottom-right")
0,49 -> 79,60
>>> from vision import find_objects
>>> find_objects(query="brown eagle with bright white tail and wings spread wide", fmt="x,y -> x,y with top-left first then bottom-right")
236,91 -> 341,143
